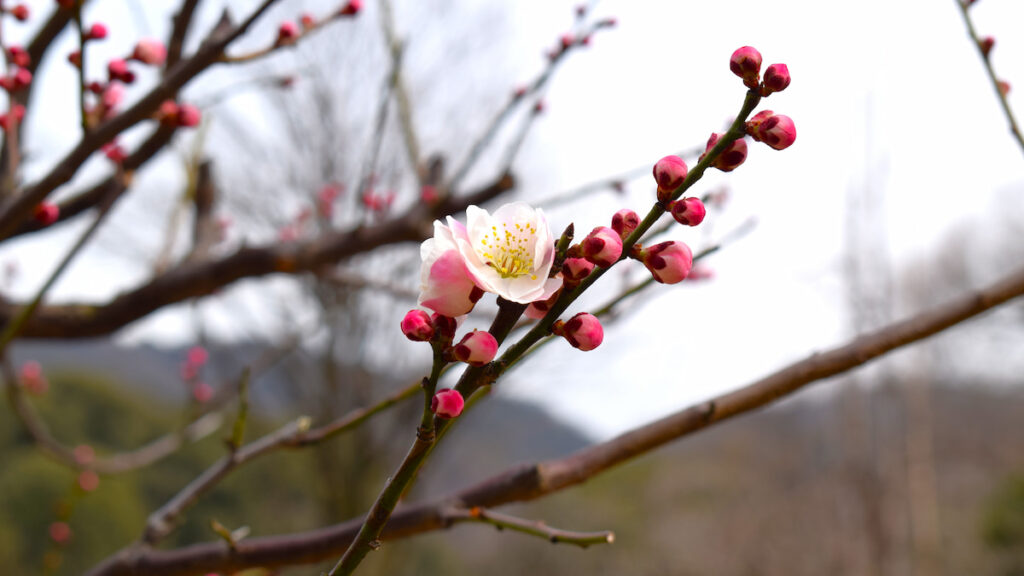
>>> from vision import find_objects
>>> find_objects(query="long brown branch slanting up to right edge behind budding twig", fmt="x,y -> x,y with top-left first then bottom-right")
88,260 -> 1024,576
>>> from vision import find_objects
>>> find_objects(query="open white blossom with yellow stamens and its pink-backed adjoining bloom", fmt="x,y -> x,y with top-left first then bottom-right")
420,202 -> 561,316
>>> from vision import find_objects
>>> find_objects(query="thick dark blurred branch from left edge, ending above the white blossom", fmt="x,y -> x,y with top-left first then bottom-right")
0,174 -> 515,338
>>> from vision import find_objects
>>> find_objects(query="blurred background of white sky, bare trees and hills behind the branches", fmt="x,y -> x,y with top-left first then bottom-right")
0,0 -> 1024,576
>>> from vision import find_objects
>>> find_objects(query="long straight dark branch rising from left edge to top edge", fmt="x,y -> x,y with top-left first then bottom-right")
0,0 -> 278,238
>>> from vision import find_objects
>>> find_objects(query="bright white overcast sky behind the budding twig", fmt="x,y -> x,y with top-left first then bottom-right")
0,0 -> 1024,436
